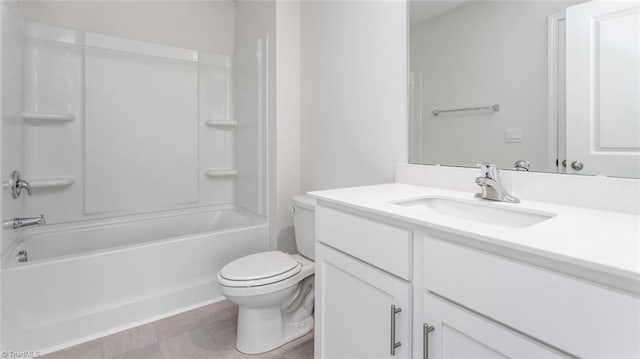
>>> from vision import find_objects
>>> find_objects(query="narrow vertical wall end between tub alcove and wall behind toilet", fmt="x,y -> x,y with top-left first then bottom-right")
271,1 -> 300,253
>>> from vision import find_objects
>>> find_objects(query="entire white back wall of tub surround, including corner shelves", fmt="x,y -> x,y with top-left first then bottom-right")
24,23 -> 236,223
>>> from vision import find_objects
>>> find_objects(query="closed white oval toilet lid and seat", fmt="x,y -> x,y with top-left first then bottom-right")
218,251 -> 302,288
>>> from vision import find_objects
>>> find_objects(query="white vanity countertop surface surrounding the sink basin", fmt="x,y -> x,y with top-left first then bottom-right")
309,183 -> 640,293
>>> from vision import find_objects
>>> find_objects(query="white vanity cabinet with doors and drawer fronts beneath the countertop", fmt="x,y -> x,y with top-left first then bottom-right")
316,201 -> 640,359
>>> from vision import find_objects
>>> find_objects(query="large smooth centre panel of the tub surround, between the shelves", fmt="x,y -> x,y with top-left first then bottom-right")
84,37 -> 199,213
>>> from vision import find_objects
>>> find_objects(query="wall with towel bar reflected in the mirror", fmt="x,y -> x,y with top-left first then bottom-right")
410,1 -> 576,170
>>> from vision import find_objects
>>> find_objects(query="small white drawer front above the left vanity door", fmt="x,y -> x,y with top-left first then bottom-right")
316,205 -> 412,280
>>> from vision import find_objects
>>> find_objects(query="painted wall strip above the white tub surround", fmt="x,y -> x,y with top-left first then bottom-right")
20,0 -> 235,55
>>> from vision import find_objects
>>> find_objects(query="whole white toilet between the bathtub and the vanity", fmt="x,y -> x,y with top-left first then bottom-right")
218,195 -> 315,354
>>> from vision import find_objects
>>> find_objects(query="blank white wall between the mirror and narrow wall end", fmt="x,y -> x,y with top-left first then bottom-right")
300,1 -> 408,191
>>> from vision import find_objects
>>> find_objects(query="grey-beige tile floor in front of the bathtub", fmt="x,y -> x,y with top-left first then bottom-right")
42,300 -> 313,359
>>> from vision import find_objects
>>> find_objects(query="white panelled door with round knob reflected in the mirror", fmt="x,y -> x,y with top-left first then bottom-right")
566,1 -> 640,177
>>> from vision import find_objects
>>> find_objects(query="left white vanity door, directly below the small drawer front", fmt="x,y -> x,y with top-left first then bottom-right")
315,243 -> 411,359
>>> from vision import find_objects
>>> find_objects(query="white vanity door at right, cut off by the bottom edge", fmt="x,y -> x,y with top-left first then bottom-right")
423,294 -> 564,359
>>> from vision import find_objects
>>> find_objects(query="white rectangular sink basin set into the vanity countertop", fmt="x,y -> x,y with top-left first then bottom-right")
391,196 -> 555,228
